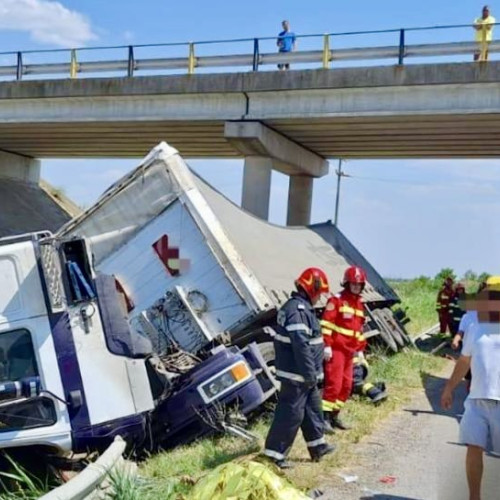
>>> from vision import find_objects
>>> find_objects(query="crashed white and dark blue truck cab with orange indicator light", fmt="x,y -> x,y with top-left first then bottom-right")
0,233 -> 274,456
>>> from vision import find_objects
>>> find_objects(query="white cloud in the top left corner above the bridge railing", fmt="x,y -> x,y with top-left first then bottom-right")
0,0 -> 97,48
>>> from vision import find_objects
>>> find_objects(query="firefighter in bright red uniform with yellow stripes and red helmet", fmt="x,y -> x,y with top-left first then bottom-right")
321,266 -> 366,432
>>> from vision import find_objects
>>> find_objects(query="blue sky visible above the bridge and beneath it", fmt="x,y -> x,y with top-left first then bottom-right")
0,0 -> 500,278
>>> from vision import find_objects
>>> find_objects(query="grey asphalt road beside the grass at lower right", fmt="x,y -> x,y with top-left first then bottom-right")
320,362 -> 500,500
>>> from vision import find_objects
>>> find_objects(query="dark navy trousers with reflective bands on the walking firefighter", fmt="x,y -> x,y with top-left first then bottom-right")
264,381 -> 326,460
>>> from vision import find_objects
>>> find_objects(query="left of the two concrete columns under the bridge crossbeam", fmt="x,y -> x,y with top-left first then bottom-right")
241,156 -> 273,220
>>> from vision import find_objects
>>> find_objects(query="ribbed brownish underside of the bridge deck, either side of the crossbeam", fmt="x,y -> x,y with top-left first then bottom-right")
0,113 -> 500,158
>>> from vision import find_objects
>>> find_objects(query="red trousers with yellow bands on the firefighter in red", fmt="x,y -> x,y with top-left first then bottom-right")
322,349 -> 353,412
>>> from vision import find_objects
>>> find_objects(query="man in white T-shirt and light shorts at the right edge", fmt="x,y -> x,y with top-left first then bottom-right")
441,276 -> 500,500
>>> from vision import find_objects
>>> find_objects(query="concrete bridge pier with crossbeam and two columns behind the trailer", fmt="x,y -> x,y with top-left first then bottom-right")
224,121 -> 328,225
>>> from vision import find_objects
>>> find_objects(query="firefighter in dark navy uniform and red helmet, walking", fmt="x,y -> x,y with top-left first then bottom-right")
264,267 -> 335,468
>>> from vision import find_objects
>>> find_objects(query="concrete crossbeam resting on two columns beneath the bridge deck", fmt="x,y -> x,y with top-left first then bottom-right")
224,121 -> 328,177
